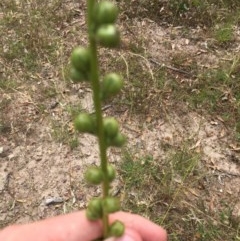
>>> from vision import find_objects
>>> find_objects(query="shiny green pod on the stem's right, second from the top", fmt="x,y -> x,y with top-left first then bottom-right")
96,24 -> 120,48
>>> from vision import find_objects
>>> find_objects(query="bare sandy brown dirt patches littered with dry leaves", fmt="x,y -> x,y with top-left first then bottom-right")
0,0 -> 240,237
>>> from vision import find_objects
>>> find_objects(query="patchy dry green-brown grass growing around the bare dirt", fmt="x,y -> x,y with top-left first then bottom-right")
0,0 -> 240,241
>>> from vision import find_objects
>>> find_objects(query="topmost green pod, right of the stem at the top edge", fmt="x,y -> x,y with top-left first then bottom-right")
95,1 -> 118,25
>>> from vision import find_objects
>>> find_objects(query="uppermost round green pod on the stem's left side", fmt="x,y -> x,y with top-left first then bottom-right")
70,47 -> 91,73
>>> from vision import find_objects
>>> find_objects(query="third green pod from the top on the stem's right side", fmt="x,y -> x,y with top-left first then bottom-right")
102,73 -> 123,99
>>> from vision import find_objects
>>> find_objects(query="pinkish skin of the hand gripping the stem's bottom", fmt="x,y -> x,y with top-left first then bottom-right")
0,211 -> 167,241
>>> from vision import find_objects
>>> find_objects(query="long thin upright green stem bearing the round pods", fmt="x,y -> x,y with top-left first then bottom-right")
87,0 -> 109,238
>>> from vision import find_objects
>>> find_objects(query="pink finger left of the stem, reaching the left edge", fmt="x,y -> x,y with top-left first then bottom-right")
0,211 -> 102,241
